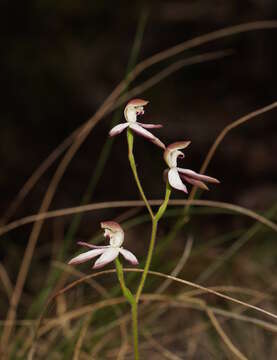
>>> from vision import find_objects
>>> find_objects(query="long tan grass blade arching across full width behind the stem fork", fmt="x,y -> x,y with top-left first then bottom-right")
0,199 -> 277,236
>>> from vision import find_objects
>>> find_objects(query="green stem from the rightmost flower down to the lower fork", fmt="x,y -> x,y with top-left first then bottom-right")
136,183 -> 171,303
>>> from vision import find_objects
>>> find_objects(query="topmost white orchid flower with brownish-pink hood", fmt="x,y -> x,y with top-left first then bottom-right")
109,99 -> 165,149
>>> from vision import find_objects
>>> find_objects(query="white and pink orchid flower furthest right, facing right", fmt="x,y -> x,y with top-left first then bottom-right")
164,141 -> 219,193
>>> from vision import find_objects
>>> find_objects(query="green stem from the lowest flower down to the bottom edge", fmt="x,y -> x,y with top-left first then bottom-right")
115,258 -> 139,360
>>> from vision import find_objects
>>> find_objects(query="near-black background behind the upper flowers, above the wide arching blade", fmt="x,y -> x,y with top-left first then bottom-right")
0,0 -> 277,296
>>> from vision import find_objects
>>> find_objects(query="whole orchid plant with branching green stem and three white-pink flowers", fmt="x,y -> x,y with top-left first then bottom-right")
69,99 -> 219,360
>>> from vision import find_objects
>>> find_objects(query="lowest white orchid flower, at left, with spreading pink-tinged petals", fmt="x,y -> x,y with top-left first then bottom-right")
68,221 -> 138,269
